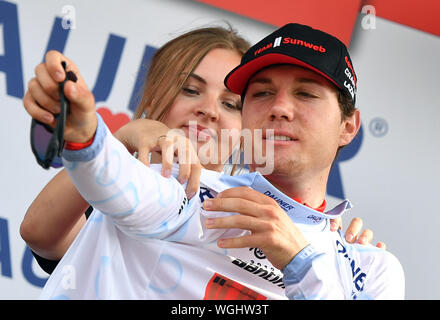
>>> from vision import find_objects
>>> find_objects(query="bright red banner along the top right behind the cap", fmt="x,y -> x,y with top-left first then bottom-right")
198,0 -> 440,46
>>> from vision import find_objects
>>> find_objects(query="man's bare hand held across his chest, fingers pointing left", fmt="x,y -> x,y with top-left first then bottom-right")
203,187 -> 308,270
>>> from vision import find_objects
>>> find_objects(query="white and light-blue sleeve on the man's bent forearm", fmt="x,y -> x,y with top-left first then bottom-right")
282,244 -> 346,300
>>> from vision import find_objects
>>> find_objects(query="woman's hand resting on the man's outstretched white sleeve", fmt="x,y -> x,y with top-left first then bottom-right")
114,119 -> 202,199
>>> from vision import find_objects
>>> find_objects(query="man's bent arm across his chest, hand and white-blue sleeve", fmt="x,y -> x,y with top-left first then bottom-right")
203,187 -> 346,299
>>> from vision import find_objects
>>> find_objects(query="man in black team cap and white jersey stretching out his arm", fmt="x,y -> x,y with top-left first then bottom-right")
39,24 -> 404,299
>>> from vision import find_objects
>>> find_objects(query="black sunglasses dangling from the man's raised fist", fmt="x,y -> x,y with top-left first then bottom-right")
31,61 -> 77,169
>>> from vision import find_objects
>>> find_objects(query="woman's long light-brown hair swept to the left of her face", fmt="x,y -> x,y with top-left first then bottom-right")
133,26 -> 250,121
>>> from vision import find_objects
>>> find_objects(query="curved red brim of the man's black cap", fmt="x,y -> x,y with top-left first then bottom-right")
225,53 -> 341,95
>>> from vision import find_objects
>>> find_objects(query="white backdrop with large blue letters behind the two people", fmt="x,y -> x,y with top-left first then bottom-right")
0,0 -> 440,299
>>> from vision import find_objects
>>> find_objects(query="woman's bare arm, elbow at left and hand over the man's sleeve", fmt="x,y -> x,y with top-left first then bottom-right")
20,119 -> 201,260
